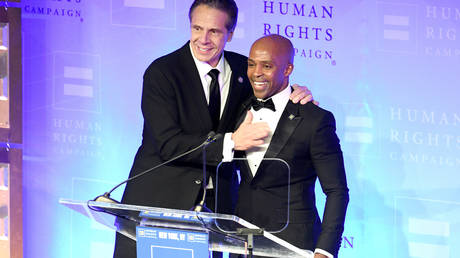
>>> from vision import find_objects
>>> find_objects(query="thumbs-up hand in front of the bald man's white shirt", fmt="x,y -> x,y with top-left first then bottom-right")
232,111 -> 270,150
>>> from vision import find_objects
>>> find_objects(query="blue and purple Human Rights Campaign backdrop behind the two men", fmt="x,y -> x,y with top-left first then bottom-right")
19,0 -> 460,257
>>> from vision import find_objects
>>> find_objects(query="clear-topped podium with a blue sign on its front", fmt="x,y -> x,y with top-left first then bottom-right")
59,199 -> 313,258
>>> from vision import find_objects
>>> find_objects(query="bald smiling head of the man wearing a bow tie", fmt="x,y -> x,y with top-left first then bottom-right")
248,35 -> 294,99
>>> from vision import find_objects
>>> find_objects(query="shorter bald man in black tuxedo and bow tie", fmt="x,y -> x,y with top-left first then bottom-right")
232,35 -> 349,258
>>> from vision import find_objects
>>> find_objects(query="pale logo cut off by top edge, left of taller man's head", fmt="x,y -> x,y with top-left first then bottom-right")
111,0 -> 177,30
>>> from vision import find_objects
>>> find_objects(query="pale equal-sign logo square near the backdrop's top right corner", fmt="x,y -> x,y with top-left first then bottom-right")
377,3 -> 418,54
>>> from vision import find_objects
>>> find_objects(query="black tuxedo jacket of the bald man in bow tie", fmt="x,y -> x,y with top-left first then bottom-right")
236,101 -> 349,257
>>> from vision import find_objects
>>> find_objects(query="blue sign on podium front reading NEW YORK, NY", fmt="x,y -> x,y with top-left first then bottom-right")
136,226 -> 209,258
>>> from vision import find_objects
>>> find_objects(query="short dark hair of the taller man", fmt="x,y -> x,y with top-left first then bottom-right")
188,0 -> 238,32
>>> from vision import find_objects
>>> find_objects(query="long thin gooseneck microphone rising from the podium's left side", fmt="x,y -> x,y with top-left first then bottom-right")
93,131 -> 222,203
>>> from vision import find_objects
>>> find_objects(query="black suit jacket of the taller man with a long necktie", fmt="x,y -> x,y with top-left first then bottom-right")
122,42 -> 252,212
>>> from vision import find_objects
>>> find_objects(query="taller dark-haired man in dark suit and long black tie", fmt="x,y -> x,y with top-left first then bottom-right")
114,0 -> 311,258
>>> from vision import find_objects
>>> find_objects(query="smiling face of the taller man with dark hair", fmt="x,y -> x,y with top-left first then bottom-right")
190,5 -> 233,67
